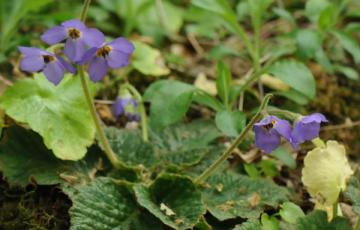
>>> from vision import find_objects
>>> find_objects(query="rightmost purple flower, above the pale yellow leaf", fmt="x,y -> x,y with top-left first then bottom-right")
291,113 -> 328,149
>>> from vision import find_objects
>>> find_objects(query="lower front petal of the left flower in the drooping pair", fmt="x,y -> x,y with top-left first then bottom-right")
254,126 -> 280,153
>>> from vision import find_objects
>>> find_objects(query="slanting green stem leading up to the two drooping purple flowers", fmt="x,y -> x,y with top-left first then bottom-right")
195,94 -> 273,184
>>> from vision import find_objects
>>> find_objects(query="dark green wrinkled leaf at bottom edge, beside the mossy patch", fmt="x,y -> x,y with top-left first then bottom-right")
65,177 -> 163,230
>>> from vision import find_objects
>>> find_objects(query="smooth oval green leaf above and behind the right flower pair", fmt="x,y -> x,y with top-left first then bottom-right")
269,60 -> 316,99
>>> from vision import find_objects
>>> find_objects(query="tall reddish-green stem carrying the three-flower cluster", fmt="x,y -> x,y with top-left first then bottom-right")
79,0 -> 125,168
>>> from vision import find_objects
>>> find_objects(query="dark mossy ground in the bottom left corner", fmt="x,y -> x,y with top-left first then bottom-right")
0,175 -> 71,230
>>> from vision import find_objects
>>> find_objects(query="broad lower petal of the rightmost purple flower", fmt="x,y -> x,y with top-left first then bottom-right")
291,121 -> 320,144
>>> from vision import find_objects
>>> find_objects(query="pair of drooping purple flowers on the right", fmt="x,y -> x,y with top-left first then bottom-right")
254,113 -> 327,153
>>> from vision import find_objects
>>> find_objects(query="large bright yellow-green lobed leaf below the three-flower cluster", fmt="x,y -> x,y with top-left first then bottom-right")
0,74 -> 95,160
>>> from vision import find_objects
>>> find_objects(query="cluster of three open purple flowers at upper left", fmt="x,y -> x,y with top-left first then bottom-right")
19,19 -> 134,85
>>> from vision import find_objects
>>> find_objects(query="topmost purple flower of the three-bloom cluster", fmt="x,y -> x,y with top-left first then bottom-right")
41,19 -> 105,62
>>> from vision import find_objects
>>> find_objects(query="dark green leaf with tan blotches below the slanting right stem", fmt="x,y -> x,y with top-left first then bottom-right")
203,172 -> 289,221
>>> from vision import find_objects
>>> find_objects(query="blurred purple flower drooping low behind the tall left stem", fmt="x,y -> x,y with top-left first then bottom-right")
113,96 -> 140,121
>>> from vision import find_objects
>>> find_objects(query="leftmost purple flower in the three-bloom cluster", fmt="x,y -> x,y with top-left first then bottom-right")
19,47 -> 75,85
